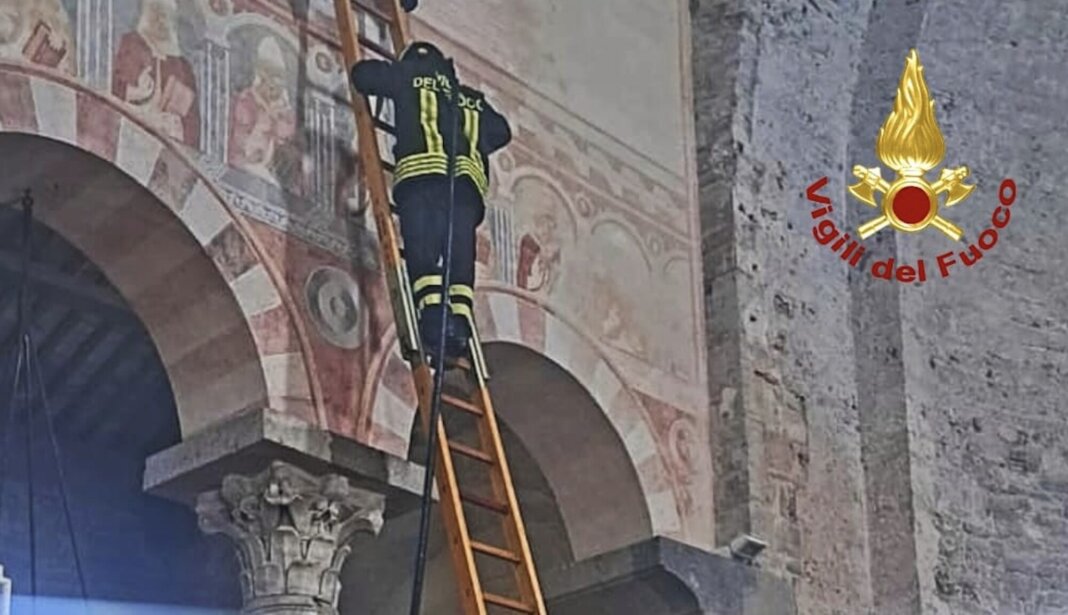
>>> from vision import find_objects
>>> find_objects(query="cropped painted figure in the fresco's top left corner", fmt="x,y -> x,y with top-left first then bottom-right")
0,0 -> 75,75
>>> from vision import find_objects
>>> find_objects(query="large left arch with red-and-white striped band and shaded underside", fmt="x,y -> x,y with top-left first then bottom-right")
0,62 -> 326,436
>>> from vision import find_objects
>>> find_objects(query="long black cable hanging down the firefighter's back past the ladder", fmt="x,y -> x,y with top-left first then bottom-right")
409,62 -> 460,615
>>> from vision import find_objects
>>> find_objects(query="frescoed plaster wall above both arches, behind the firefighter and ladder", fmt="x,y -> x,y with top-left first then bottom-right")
0,0 -> 712,545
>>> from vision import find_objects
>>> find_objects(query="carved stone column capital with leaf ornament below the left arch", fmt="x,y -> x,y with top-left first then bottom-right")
197,461 -> 386,615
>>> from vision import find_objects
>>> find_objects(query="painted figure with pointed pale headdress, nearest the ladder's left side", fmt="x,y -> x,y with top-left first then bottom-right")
229,34 -> 303,192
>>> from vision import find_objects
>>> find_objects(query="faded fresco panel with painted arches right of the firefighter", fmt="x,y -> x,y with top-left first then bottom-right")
499,167 -> 696,380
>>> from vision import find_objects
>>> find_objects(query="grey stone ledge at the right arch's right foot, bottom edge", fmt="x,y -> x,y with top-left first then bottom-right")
541,537 -> 797,615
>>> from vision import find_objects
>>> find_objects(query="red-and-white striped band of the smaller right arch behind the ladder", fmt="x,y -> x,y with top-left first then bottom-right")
364,284 -> 681,535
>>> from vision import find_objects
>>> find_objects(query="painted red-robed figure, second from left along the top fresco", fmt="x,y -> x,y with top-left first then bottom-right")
111,0 -> 200,147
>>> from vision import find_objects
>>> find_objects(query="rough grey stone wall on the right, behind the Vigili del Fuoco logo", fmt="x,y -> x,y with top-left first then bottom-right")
691,0 -> 1068,614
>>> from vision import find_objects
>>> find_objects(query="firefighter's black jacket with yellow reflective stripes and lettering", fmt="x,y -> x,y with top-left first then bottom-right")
352,55 -> 512,196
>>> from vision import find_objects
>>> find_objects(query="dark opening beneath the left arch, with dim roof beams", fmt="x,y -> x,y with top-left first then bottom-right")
0,210 -> 240,615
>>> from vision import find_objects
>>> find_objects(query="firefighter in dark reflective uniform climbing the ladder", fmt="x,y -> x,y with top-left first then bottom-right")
352,42 -> 511,358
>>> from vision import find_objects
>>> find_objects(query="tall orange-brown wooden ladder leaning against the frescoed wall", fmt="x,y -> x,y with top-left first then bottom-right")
334,0 -> 546,615
